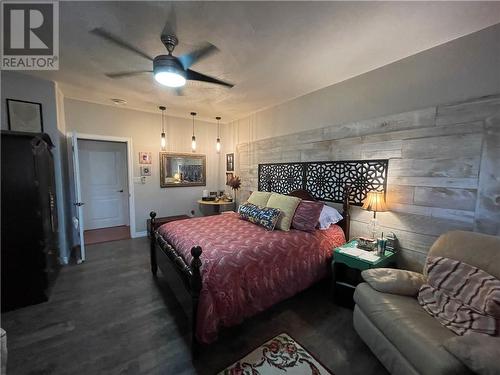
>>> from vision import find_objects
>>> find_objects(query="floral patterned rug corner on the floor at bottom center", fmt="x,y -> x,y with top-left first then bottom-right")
219,333 -> 332,375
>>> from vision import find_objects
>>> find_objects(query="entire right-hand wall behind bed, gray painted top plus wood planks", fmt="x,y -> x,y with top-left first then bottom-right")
223,25 -> 500,269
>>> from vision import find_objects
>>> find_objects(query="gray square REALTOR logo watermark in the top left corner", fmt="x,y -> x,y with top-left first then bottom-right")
1,1 -> 59,70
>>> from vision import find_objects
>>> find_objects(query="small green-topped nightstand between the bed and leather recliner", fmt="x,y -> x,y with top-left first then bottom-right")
332,240 -> 396,306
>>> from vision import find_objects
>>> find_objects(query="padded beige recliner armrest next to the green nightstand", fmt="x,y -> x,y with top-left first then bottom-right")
361,268 -> 426,297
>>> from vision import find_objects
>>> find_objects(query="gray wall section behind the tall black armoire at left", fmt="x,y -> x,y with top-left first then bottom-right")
1,71 -> 69,262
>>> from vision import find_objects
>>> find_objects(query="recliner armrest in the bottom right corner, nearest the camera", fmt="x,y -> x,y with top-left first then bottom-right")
443,333 -> 500,375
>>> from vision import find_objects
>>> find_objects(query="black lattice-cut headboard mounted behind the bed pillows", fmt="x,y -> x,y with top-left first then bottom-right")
258,159 -> 389,206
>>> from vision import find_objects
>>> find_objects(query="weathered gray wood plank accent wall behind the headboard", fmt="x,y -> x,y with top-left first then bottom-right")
236,94 -> 500,270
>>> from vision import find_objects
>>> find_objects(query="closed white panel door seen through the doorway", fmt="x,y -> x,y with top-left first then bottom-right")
78,139 -> 129,230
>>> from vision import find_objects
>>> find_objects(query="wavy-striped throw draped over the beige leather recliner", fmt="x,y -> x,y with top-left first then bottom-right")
418,256 -> 500,336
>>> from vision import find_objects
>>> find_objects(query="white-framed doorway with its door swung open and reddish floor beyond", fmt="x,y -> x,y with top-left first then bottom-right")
71,133 -> 136,262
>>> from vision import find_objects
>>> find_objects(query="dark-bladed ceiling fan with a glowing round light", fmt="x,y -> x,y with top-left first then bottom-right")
90,15 -> 234,88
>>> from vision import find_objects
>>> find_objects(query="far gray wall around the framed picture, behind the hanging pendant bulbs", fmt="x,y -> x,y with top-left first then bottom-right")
64,98 -> 223,233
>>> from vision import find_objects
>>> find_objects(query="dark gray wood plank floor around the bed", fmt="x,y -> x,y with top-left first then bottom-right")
2,238 -> 387,375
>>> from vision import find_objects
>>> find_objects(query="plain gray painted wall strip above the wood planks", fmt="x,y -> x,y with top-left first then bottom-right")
223,24 -> 500,148
